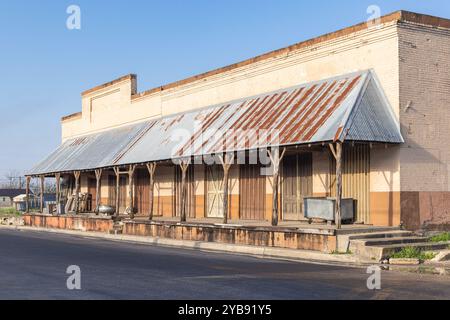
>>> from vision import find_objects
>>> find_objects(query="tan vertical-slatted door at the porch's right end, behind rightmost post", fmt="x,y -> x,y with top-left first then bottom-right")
330,145 -> 370,223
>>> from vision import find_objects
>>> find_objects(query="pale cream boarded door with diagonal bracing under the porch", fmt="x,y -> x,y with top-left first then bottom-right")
206,165 -> 223,218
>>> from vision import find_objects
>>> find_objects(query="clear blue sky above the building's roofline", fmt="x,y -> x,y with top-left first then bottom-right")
0,0 -> 450,179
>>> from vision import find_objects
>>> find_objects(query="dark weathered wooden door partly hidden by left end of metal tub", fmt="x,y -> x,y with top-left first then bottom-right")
281,153 -> 312,220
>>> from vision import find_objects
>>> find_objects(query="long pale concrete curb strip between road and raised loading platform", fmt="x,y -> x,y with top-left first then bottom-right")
0,225 -> 366,266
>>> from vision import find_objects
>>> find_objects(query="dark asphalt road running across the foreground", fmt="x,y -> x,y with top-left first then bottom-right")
0,229 -> 450,300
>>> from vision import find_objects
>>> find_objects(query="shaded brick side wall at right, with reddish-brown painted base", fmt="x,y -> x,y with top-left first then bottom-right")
398,24 -> 450,228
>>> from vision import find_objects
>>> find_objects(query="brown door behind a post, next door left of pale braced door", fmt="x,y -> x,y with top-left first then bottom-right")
175,165 -> 195,218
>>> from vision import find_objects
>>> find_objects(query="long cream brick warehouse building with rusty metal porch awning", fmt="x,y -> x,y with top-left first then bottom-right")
27,11 -> 450,240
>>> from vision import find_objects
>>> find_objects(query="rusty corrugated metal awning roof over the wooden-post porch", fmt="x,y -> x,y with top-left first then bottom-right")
30,71 -> 403,175
